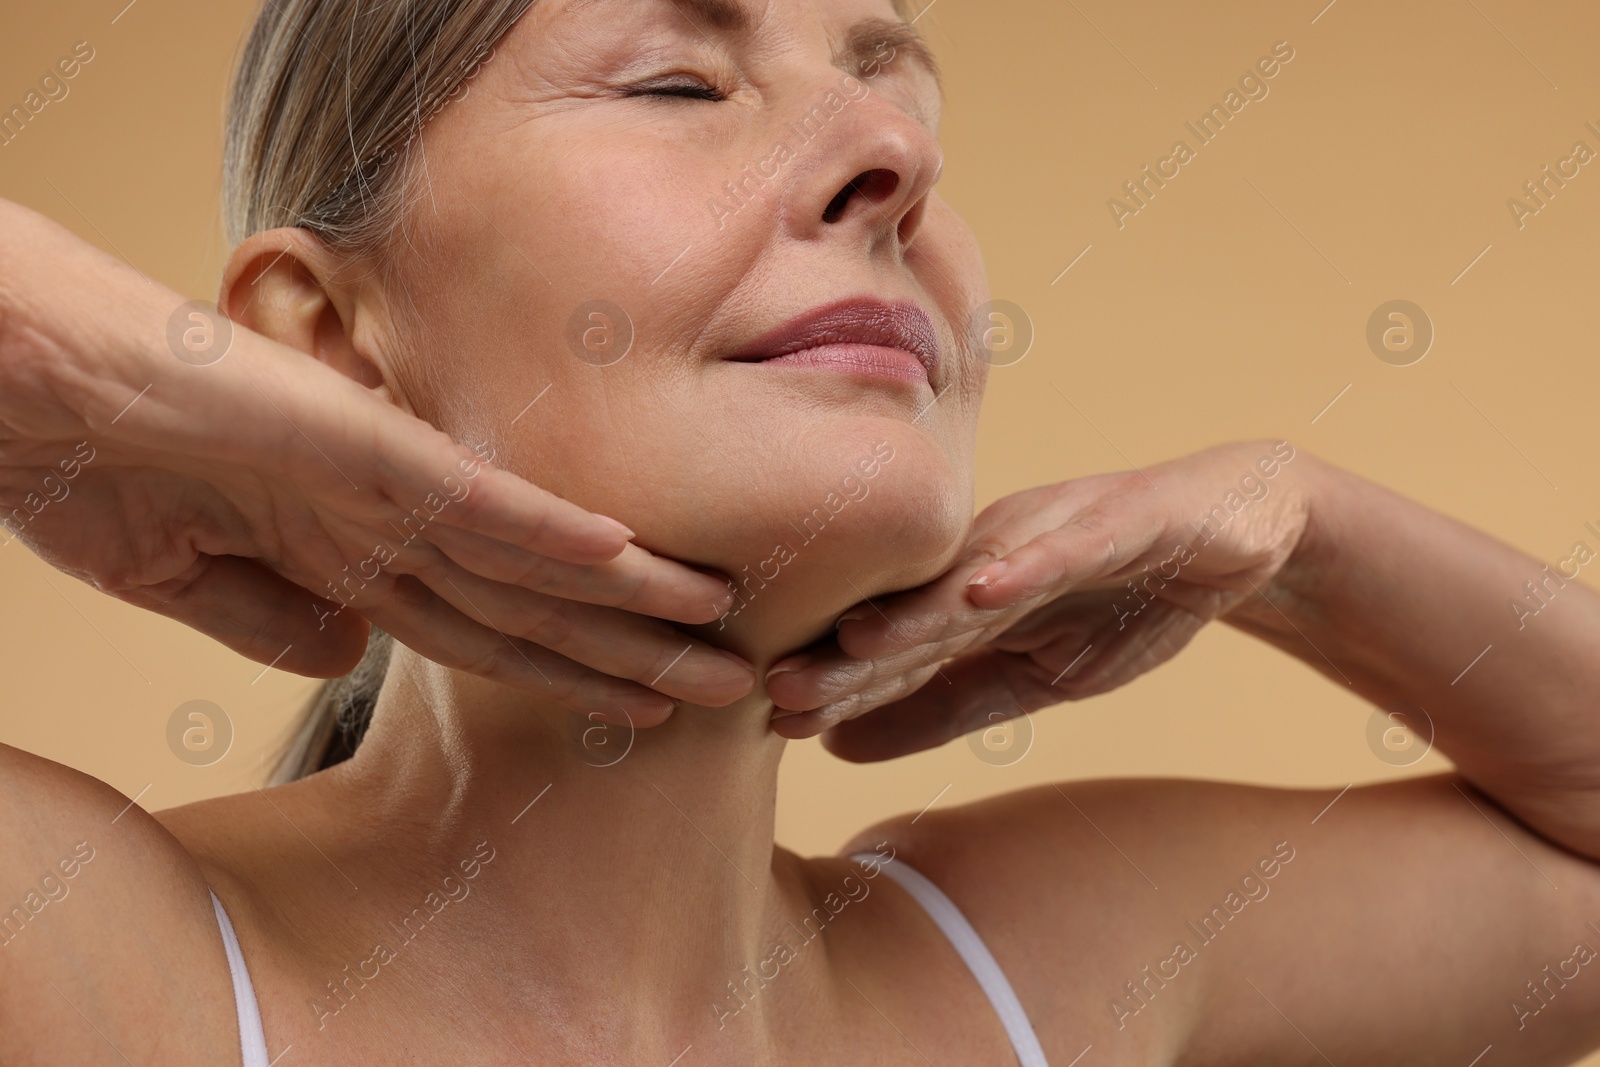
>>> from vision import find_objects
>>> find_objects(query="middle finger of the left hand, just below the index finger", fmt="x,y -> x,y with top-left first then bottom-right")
427,526 -> 733,622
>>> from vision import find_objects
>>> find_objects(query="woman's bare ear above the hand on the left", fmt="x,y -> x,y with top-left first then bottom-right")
218,229 -> 395,400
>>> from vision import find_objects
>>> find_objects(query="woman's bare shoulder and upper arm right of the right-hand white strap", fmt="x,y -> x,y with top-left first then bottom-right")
876,776 -> 1600,1067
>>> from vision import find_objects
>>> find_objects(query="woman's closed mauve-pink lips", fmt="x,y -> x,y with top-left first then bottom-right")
733,299 -> 939,381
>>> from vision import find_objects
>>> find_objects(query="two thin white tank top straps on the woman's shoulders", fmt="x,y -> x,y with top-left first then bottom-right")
211,853 -> 1050,1067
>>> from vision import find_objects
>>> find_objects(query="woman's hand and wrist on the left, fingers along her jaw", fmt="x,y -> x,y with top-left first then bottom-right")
0,200 -> 755,726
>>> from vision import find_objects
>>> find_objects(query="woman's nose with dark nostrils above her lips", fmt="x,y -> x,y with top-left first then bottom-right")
782,78 -> 944,254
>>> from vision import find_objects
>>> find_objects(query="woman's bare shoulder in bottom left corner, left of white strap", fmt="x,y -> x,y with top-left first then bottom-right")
0,744 -> 249,1064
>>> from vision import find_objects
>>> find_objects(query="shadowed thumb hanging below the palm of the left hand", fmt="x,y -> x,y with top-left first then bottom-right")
117,555 -> 368,678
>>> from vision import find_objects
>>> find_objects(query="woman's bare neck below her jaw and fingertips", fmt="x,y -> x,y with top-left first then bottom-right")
338,646 -> 816,1062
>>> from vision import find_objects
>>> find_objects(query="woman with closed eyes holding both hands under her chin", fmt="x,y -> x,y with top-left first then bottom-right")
0,0 -> 1600,1065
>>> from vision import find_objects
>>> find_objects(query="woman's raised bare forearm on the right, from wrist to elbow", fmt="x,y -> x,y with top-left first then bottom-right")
1229,459 -> 1600,857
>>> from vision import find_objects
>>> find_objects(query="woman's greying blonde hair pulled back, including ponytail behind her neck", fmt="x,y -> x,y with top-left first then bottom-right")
222,0 -> 931,784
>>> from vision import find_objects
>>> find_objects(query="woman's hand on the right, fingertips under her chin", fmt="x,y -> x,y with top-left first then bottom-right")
768,442 -> 1317,761
